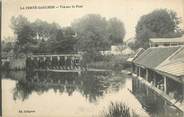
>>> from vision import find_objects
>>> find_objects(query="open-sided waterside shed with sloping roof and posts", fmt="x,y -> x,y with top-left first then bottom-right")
128,46 -> 184,112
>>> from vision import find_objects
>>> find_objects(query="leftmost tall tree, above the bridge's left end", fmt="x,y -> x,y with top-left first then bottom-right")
11,16 -> 36,55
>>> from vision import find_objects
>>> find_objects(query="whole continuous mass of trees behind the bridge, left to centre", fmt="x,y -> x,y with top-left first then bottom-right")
11,14 -> 125,61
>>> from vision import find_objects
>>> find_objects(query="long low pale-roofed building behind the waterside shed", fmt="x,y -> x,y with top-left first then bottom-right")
149,36 -> 184,47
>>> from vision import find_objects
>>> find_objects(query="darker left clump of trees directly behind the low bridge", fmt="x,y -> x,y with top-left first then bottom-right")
11,15 -> 77,54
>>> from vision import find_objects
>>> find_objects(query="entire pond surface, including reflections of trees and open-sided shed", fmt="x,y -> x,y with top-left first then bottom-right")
3,72 -> 182,117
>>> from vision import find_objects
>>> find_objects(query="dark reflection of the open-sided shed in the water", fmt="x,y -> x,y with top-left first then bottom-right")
132,78 -> 183,117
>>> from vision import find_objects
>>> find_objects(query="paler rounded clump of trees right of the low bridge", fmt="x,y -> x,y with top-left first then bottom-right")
72,14 -> 125,52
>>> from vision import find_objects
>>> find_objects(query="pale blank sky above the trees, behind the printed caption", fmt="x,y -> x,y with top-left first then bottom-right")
2,0 -> 184,40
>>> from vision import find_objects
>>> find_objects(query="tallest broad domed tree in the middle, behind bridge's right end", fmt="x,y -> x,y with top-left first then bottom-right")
72,14 -> 110,52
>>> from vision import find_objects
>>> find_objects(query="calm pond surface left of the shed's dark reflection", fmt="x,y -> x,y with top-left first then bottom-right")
2,72 -> 181,117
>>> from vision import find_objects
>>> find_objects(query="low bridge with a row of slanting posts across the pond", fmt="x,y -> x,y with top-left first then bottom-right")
26,54 -> 86,70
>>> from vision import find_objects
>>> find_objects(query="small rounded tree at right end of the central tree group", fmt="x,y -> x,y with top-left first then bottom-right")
107,18 -> 125,45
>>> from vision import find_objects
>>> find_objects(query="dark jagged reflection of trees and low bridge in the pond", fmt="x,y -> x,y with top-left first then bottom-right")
13,72 -> 111,102
